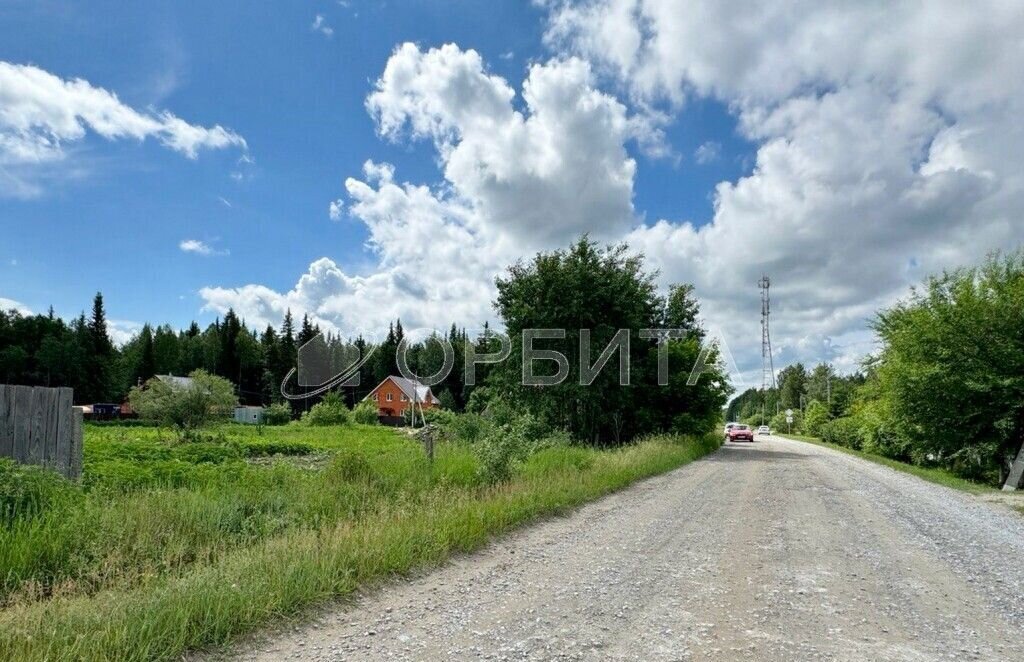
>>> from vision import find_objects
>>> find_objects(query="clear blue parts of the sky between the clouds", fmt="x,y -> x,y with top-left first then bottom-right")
0,0 -> 753,338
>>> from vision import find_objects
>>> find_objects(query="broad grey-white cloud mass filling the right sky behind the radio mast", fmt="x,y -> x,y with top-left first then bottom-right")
547,0 -> 1024,377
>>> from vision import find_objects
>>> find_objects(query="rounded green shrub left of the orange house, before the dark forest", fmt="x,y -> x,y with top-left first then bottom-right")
128,370 -> 238,435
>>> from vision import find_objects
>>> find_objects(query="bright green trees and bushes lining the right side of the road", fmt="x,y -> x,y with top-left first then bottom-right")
727,252 -> 1024,487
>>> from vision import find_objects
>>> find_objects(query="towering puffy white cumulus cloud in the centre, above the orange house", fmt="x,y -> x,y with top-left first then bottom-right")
200,44 -> 644,334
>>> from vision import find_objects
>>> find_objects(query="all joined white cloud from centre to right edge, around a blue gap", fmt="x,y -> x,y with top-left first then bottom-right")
201,6 -> 1024,379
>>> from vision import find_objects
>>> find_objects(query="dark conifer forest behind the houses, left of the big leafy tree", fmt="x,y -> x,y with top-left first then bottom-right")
0,293 -> 472,409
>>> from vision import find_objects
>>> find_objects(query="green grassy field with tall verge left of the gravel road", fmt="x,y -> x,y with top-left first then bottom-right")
0,424 -> 719,660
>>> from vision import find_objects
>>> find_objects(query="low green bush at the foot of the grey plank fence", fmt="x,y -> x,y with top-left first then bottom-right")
0,458 -> 81,525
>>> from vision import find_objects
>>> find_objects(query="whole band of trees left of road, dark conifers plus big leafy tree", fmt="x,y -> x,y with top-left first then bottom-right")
0,237 -> 731,444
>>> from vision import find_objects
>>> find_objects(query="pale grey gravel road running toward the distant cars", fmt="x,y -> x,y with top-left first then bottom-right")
228,438 -> 1024,661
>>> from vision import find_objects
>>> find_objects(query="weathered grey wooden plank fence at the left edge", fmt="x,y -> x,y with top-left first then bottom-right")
0,384 -> 82,479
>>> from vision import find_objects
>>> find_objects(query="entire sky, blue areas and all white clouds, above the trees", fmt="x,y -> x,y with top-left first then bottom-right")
0,0 -> 1024,376
